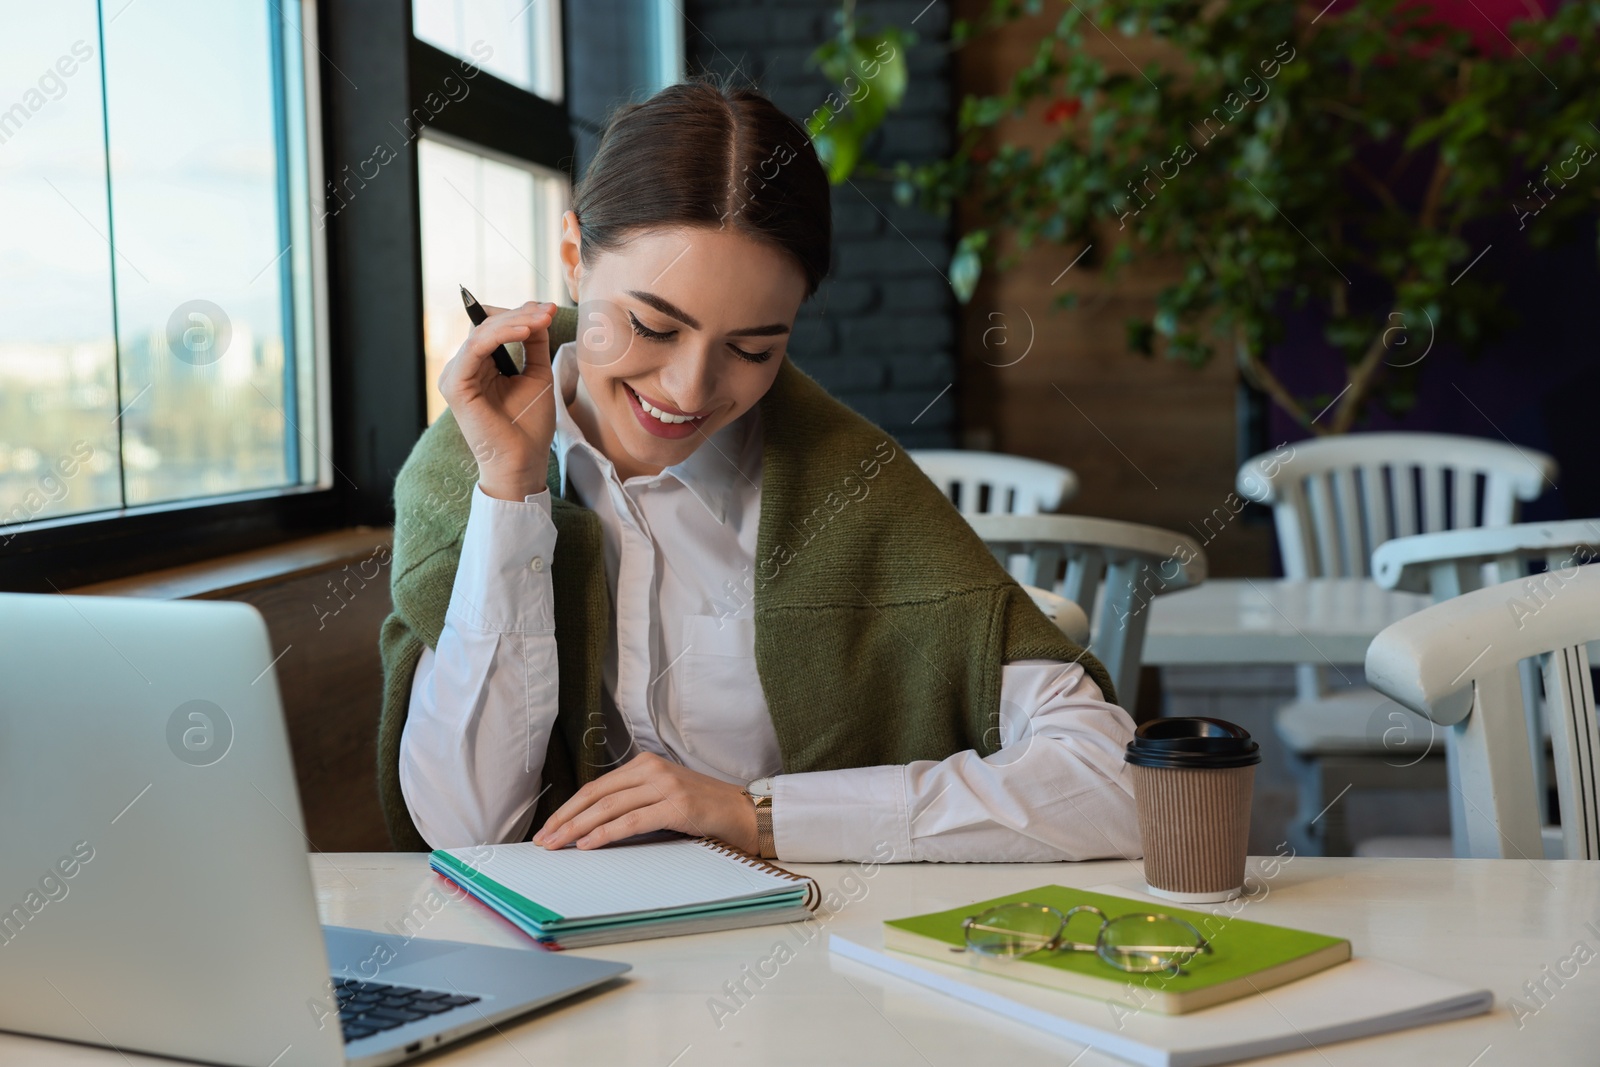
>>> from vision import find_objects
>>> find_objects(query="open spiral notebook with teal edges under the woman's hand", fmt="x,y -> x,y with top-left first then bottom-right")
429,837 -> 821,949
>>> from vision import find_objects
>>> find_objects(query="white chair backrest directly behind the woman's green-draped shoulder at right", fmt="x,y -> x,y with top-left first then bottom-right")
968,515 -> 1206,707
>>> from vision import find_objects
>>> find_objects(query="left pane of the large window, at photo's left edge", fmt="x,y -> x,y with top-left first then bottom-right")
0,0 -> 122,525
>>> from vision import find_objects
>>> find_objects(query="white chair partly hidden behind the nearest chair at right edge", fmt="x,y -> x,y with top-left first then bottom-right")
1373,518 -> 1600,856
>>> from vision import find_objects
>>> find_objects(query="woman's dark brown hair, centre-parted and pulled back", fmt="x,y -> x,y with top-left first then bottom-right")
573,75 -> 834,299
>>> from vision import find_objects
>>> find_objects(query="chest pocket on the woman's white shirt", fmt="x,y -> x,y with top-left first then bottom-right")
675,614 -> 779,781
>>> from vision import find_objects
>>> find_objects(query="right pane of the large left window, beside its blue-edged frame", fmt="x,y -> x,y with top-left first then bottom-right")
106,0 -> 308,504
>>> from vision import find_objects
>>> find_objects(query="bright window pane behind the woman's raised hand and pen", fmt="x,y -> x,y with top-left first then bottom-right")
418,133 -> 570,422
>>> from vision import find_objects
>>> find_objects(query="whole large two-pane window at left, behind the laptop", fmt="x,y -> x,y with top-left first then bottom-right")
0,0 -> 331,544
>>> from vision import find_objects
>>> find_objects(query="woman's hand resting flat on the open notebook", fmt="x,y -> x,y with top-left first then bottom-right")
533,752 -> 758,856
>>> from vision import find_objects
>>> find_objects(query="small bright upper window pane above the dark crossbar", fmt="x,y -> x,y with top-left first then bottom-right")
411,0 -> 562,101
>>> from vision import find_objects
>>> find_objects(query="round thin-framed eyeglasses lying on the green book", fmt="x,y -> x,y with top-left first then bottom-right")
957,902 -> 1211,976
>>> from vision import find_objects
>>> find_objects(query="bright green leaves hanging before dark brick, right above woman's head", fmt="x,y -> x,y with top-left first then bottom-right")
806,0 -> 917,186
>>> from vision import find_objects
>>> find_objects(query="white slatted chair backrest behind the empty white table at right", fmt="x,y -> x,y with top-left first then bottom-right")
1237,434 -> 1557,577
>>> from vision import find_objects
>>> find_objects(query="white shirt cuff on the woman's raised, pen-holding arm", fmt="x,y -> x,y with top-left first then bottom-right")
446,485 -> 555,633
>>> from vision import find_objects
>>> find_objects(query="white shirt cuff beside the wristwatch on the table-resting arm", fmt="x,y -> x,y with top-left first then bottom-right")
773,766 -> 915,864
